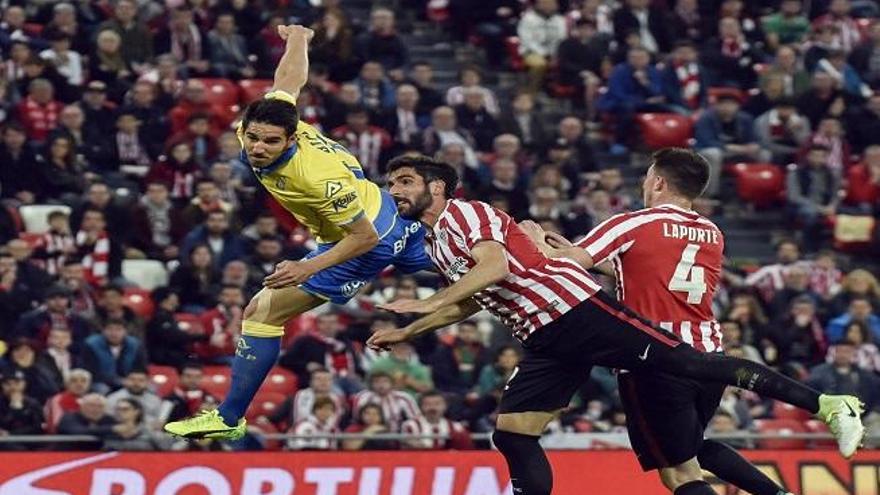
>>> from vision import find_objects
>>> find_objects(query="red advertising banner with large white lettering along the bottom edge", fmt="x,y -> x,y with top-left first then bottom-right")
0,451 -> 880,495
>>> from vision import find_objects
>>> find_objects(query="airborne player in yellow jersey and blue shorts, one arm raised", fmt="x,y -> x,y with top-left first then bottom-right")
165,26 -> 431,439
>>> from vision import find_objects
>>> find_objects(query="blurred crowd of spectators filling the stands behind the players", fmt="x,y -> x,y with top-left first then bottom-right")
0,0 -> 880,450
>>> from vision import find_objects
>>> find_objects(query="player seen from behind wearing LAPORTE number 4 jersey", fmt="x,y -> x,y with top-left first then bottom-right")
521,148 -> 859,495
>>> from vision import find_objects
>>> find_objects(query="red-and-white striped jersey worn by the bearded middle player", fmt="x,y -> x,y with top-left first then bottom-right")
426,199 -> 601,341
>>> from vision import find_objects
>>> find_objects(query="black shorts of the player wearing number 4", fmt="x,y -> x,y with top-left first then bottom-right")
617,371 -> 726,471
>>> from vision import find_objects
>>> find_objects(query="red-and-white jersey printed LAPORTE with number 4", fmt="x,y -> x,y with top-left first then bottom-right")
577,205 -> 724,352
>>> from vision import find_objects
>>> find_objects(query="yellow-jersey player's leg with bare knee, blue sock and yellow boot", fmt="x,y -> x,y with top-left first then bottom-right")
165,286 -> 325,440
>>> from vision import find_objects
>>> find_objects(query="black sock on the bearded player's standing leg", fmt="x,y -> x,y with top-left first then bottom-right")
492,430 -> 553,495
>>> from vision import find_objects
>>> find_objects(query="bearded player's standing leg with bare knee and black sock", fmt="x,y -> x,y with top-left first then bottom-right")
492,411 -> 559,495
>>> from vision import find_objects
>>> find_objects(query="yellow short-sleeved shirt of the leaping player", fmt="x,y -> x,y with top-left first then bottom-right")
238,91 -> 382,243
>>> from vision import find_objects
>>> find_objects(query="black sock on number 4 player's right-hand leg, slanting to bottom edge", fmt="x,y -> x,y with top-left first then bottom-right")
697,440 -> 785,495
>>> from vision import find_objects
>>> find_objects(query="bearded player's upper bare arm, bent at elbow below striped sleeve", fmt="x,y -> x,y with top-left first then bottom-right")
379,241 -> 510,313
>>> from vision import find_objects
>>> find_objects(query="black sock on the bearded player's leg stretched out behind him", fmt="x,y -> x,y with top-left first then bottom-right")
658,345 -> 819,414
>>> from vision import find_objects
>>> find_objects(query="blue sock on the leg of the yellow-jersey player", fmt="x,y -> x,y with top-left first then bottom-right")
217,335 -> 281,426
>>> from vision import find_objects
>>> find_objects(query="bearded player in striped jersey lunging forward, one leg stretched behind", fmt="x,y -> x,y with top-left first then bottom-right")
367,156 -> 864,495
